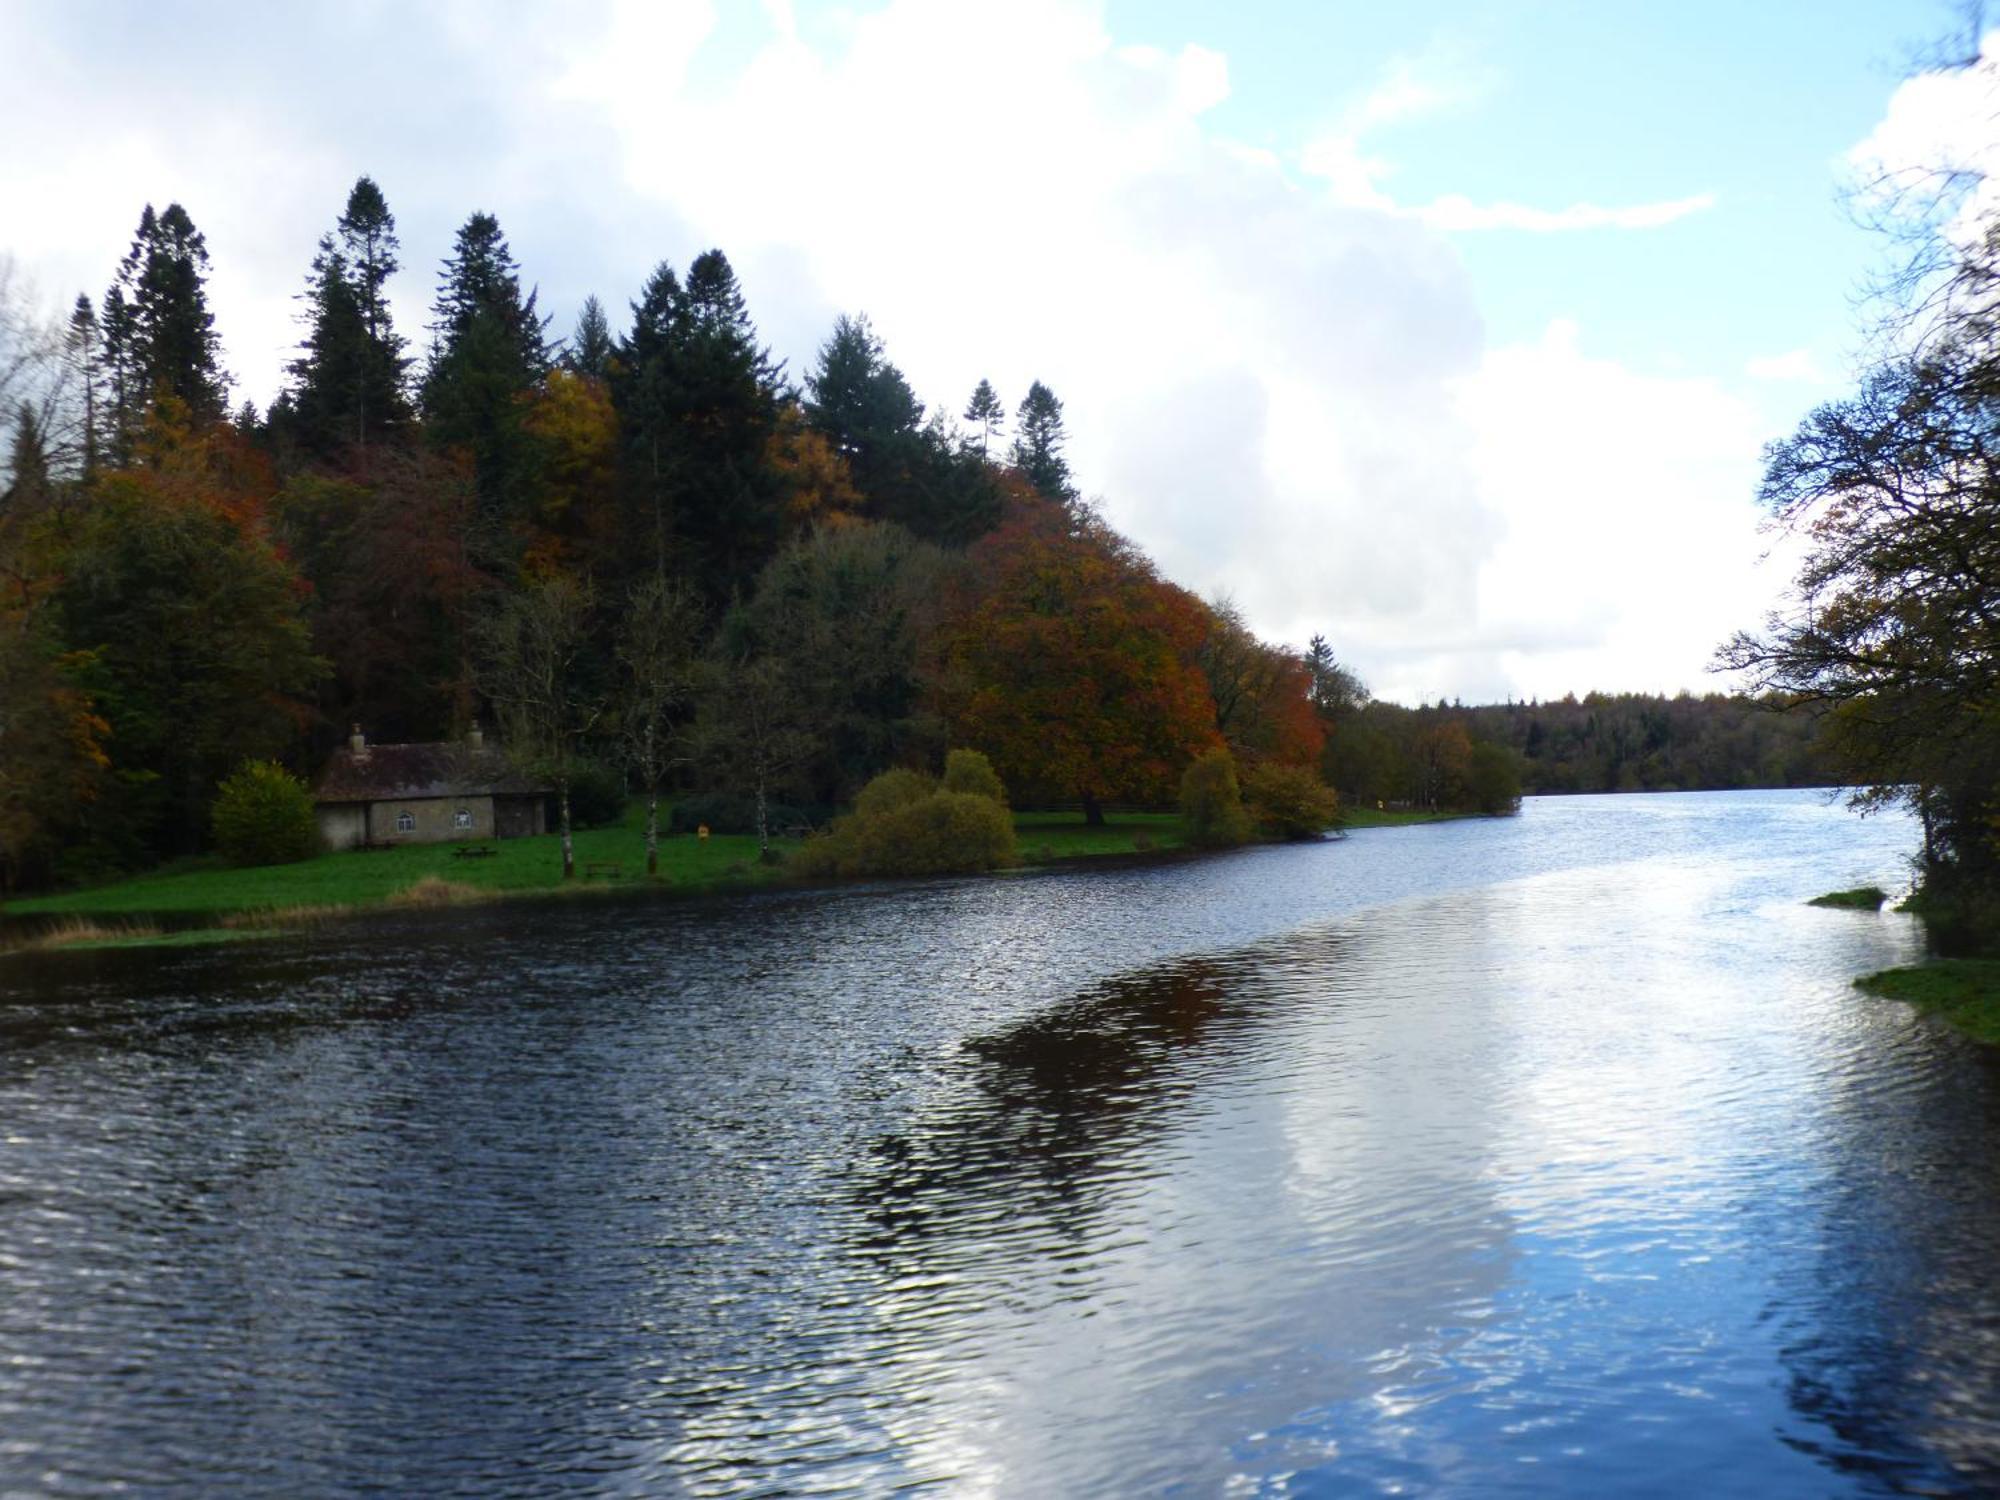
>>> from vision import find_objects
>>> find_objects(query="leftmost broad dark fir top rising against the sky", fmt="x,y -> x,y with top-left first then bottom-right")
106,204 -> 230,444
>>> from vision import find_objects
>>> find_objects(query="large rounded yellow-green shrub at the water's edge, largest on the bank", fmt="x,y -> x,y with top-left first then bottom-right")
794,770 -> 1014,876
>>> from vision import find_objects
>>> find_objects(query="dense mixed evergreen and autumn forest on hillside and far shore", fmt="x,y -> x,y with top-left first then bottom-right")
0,178 -> 1812,890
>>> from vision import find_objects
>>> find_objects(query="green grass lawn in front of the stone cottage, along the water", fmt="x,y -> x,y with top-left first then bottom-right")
6,808 -> 782,916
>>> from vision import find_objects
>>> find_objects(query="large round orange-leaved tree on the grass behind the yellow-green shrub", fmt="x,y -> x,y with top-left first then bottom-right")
946,494 -> 1216,824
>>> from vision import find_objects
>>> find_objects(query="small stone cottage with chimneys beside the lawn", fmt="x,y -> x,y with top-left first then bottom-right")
312,724 -> 548,848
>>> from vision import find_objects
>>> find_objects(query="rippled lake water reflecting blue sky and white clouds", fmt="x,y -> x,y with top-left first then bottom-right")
0,792 -> 2000,1500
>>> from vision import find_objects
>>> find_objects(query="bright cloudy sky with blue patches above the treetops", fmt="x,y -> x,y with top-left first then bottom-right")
0,0 -> 1964,702
